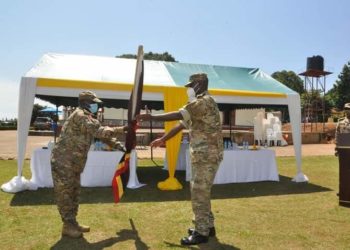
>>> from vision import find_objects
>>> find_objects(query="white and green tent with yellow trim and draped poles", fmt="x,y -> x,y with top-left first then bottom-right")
17,53 -> 307,189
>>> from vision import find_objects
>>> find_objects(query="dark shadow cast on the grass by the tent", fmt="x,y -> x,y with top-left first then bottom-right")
11,167 -> 332,206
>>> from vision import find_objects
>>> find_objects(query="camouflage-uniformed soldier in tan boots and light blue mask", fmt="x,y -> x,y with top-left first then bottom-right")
51,91 -> 127,238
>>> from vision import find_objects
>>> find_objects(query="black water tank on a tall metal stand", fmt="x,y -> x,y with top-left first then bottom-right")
299,55 -> 332,132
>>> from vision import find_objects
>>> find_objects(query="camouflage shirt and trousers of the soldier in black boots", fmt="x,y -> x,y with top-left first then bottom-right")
180,92 -> 224,235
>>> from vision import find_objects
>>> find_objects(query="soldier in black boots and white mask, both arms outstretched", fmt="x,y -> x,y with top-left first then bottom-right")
138,73 -> 223,245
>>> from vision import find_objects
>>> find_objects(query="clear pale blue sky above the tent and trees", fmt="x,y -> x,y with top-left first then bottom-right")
0,0 -> 350,119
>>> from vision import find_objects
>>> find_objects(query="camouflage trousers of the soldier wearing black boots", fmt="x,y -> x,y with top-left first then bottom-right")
191,161 -> 219,235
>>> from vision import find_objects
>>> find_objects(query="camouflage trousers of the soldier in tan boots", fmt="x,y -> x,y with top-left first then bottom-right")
51,161 -> 80,222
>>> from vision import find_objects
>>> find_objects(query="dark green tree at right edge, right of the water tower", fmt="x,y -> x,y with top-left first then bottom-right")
327,61 -> 350,110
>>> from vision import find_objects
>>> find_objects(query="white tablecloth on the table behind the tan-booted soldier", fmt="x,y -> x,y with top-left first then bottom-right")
30,149 -> 139,188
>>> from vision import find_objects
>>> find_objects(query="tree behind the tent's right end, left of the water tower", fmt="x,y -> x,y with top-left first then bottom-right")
271,70 -> 305,94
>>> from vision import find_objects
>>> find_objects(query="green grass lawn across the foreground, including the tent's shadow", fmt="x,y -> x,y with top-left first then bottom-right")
0,156 -> 350,249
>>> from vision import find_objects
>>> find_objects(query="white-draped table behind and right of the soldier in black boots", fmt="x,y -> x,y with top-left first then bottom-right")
186,149 -> 279,184
